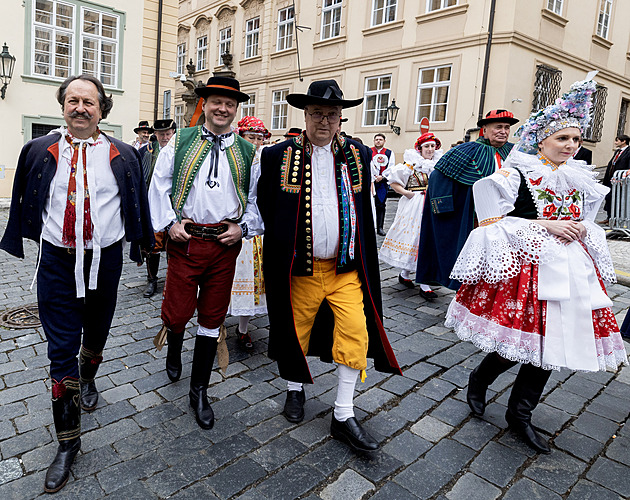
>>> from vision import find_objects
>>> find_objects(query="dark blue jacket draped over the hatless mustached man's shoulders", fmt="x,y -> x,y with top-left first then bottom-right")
0,134 -> 153,262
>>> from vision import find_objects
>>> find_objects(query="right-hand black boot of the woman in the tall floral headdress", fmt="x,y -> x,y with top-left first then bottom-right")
505,364 -> 551,453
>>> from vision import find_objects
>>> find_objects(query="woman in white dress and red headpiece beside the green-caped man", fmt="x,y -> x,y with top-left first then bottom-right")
378,132 -> 442,300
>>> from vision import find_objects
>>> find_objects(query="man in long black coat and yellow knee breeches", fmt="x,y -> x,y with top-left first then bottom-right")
258,80 -> 400,451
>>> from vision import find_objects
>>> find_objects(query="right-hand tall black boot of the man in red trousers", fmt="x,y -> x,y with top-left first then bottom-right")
188,335 -> 218,429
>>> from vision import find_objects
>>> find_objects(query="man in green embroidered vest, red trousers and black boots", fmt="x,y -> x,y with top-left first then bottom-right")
149,76 -> 262,429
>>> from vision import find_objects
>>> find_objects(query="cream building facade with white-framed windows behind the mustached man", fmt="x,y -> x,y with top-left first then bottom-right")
0,0 -> 178,199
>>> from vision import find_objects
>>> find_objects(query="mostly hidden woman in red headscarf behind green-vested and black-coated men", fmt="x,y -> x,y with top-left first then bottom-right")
228,116 -> 271,352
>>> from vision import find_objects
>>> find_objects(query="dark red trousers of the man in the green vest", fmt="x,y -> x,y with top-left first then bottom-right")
162,237 -> 241,333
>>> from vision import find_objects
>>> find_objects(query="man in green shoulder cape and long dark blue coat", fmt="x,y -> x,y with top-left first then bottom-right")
416,109 -> 518,290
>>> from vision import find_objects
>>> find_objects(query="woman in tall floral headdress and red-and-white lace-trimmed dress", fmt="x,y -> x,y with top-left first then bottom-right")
446,80 -> 628,453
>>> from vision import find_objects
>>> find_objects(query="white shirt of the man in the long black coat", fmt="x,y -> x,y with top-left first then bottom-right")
312,144 -> 339,259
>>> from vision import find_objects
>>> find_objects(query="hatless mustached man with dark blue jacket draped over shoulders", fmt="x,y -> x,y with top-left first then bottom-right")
0,75 -> 153,493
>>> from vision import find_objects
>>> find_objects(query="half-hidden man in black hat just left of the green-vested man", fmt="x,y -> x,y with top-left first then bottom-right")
139,119 -> 177,298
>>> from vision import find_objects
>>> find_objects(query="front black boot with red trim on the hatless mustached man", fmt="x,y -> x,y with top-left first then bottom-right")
44,378 -> 81,493
